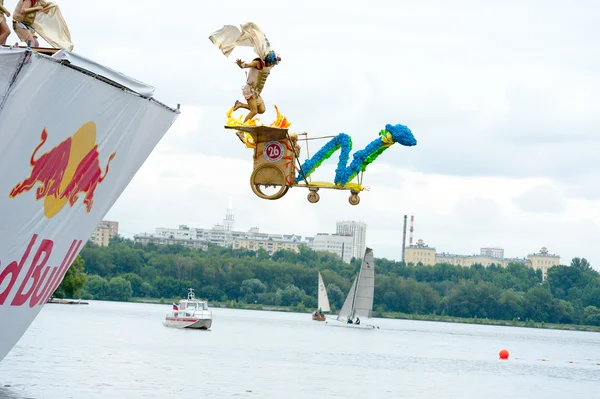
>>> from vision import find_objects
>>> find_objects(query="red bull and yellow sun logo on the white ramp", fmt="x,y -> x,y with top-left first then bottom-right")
9,122 -> 116,218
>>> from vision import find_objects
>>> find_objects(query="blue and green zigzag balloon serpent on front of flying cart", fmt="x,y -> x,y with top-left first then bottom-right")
295,124 -> 417,186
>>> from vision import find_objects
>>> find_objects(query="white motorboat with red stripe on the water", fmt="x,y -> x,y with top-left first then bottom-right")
163,288 -> 212,330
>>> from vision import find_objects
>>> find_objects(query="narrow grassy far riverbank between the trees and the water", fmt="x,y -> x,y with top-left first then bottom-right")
131,298 -> 600,332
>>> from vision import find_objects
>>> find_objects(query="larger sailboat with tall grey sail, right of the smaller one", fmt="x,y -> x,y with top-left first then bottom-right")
336,248 -> 375,328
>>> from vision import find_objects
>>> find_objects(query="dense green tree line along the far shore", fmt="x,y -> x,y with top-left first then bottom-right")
55,237 -> 600,326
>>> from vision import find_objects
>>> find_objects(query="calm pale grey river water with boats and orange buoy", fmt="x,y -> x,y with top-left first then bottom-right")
0,301 -> 600,399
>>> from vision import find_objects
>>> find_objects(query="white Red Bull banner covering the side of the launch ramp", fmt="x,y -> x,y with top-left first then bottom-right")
0,50 -> 178,360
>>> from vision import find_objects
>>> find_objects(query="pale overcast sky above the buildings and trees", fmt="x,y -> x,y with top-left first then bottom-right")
5,0 -> 600,270
